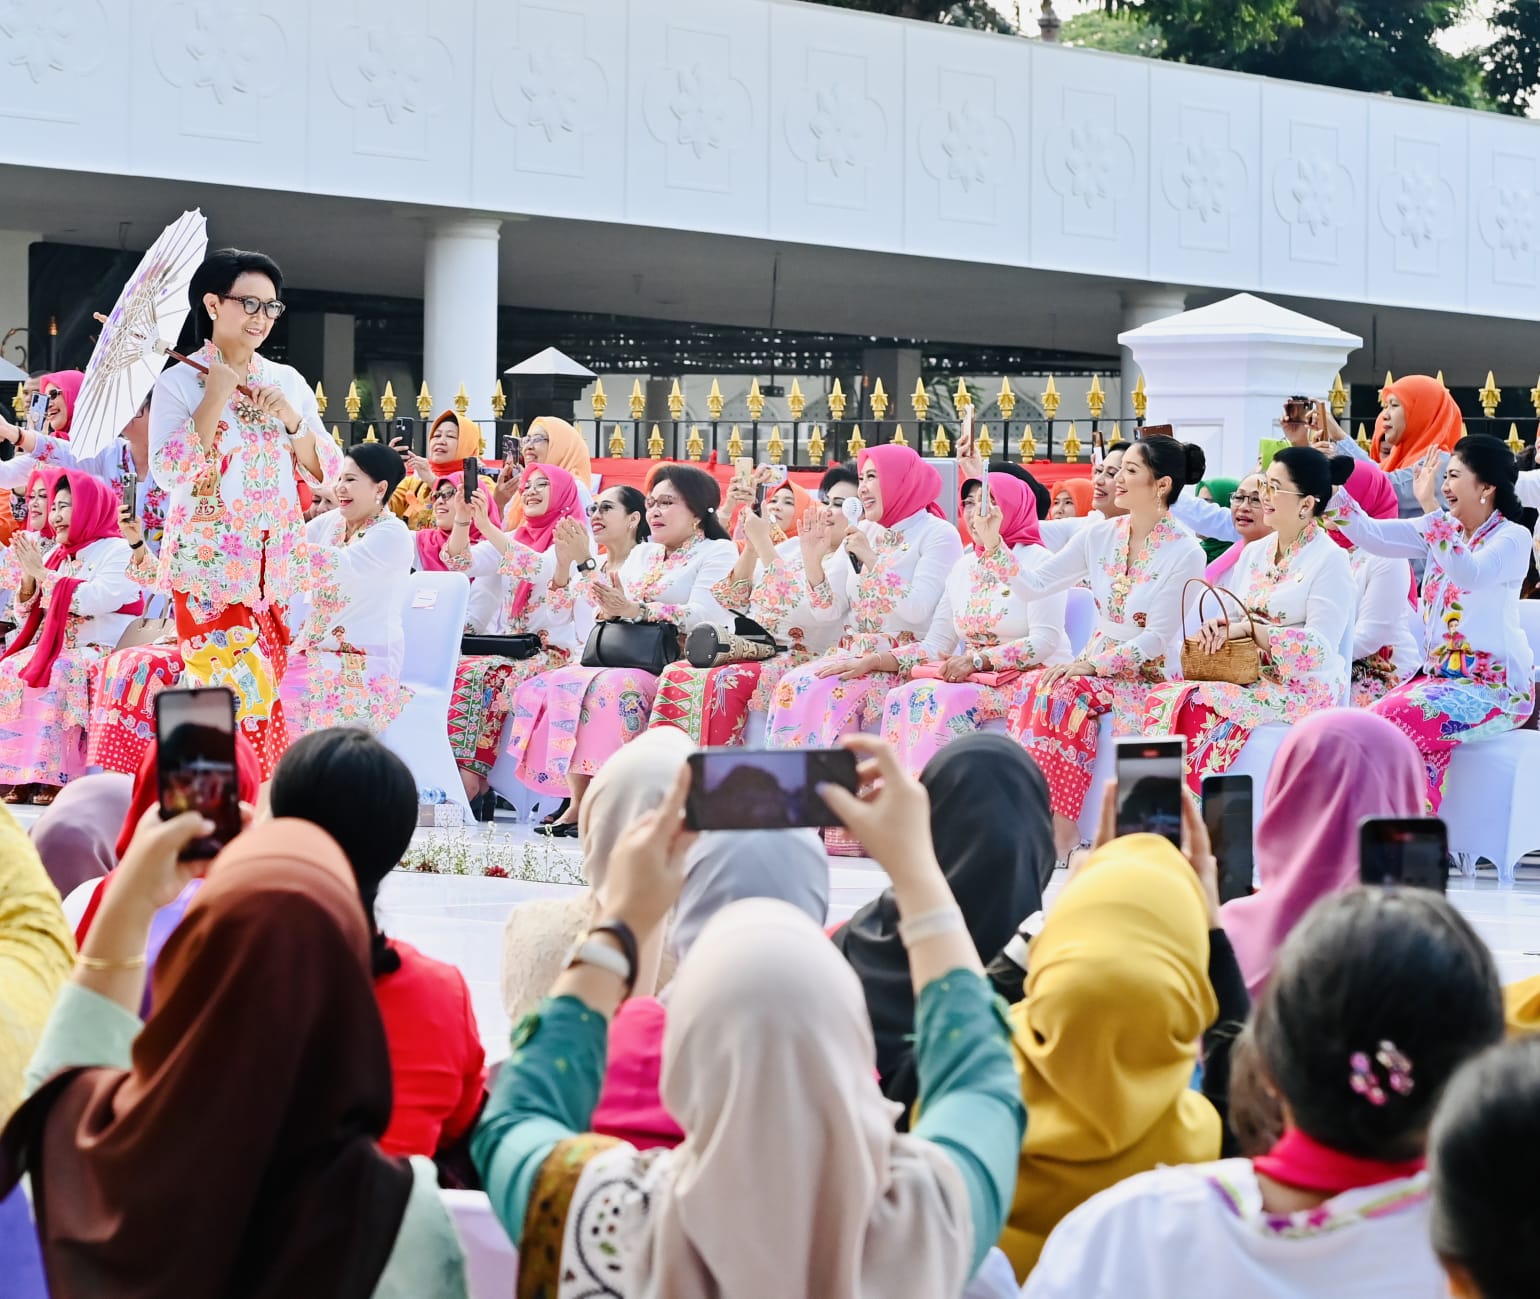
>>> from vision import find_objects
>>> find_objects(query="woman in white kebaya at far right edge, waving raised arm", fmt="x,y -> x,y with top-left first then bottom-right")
1332,436 -> 1534,816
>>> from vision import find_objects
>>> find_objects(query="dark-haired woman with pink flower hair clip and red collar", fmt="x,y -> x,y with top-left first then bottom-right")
1023,888 -> 1503,1299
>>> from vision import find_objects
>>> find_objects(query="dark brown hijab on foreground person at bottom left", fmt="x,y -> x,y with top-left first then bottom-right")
0,820 -> 413,1299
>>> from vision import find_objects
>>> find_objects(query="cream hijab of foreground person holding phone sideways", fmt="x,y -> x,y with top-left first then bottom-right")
628,899 -> 973,1299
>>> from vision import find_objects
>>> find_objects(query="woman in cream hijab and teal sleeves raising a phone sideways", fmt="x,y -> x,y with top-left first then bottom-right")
473,737 -> 1026,1299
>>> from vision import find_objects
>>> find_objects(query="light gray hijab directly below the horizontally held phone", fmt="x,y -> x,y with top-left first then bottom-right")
670,830 -> 829,960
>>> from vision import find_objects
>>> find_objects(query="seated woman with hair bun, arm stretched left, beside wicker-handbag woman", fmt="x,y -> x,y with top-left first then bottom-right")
979,436 -> 1204,859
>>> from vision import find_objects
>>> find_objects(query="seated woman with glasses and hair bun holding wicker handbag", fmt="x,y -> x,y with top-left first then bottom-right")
1144,446 -> 1358,796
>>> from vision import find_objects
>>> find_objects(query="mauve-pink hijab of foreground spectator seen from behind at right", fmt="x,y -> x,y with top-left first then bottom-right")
1220,708 -> 1428,997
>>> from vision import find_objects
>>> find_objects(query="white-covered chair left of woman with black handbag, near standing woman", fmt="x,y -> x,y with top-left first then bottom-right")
380,573 -> 471,820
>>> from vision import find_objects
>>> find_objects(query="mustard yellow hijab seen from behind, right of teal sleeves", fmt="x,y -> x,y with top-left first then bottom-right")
999,834 -> 1220,1281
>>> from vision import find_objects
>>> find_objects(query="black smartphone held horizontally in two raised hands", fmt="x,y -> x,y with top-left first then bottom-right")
684,748 -> 858,830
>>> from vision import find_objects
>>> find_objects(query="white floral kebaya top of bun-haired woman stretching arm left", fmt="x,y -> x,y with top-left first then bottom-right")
1012,514 -> 1204,680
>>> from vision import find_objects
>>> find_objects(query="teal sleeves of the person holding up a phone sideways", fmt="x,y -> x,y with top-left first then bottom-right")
471,970 -> 1027,1268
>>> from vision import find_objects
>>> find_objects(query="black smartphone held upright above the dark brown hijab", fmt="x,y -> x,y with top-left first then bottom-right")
156,686 -> 240,860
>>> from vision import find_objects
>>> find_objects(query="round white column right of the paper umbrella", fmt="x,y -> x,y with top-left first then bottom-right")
422,217 -> 502,420
